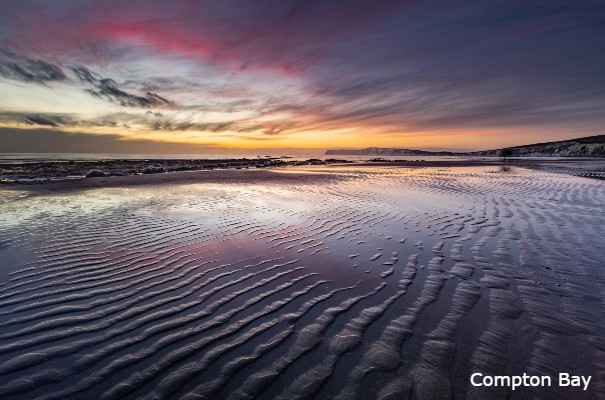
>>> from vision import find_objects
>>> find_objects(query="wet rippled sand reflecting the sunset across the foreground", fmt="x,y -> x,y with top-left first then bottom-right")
0,163 -> 605,399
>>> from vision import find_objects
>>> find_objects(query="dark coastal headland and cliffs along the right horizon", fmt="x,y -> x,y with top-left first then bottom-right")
326,135 -> 605,157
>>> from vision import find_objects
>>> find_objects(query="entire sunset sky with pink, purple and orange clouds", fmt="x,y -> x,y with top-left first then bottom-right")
0,0 -> 605,153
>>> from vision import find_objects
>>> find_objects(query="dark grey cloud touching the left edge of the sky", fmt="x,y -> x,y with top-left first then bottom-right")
0,48 -> 67,83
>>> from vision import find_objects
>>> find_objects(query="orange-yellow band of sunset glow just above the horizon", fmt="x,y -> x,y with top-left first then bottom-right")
0,123 -> 584,151
